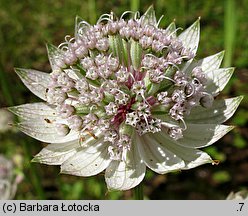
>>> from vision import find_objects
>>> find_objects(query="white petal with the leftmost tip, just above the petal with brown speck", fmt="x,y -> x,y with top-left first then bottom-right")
8,102 -> 58,122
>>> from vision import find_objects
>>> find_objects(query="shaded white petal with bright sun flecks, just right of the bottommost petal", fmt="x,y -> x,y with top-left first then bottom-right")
137,134 -> 185,174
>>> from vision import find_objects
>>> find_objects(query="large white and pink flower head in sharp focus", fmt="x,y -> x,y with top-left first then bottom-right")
10,7 -> 242,190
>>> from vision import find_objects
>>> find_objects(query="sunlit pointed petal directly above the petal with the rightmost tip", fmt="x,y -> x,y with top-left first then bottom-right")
206,68 -> 234,95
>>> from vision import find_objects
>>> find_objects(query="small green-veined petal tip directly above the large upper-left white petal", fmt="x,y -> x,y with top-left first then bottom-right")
46,44 -> 63,70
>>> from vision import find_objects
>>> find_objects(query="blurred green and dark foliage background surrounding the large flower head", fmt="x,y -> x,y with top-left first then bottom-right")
0,0 -> 248,199
